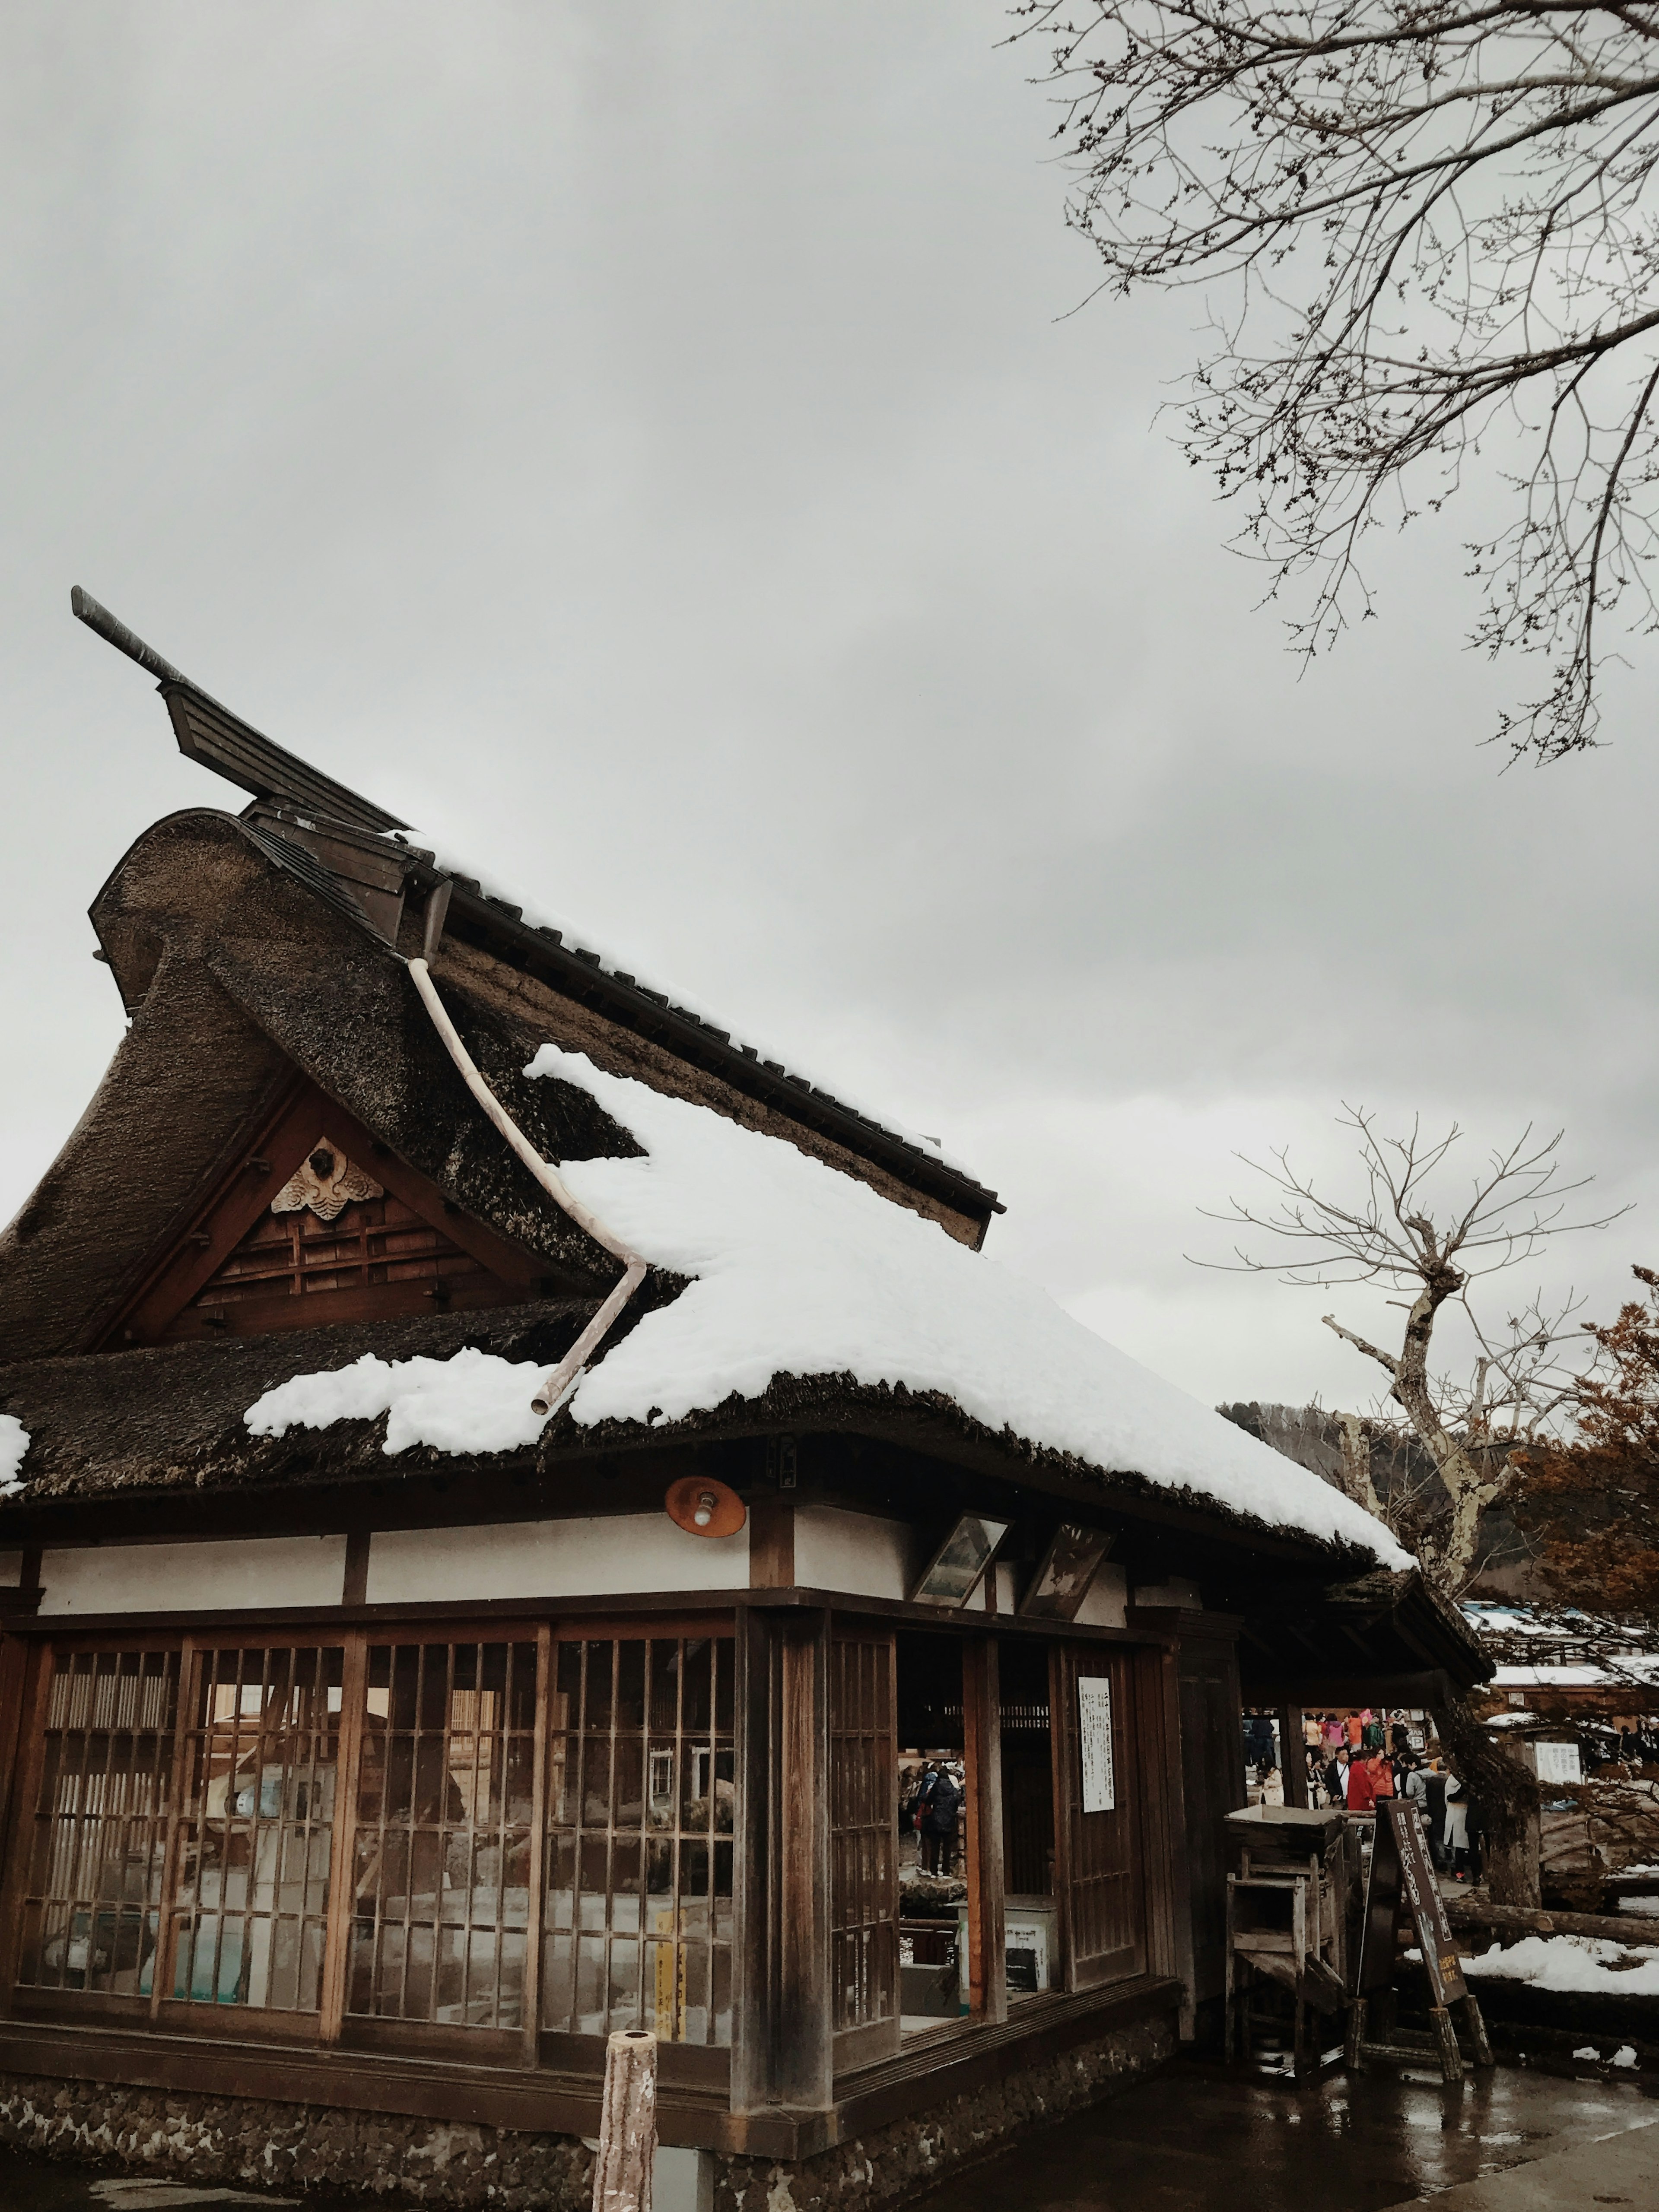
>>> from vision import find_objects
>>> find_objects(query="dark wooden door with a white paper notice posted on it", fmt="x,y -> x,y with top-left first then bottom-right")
1051,1644 -> 1146,1989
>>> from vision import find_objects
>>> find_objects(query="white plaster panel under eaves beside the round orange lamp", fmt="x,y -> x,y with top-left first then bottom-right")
369,1513 -> 750,1606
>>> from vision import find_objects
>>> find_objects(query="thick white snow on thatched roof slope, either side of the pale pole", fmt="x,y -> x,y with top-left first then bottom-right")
245,1044 -> 1414,1568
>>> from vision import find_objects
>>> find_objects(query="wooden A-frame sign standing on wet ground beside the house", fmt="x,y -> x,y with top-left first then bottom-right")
1347,1798 -> 1493,2082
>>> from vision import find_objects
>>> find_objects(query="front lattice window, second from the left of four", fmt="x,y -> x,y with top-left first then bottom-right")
169,1646 -> 345,2013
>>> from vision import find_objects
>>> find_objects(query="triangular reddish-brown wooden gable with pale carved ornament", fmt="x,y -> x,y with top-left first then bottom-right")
99,1084 -> 549,1352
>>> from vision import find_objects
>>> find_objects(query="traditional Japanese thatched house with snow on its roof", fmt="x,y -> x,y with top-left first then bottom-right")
0,606 -> 1482,2212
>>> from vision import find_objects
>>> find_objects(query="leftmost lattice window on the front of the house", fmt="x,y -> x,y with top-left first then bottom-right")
18,1650 -> 179,1997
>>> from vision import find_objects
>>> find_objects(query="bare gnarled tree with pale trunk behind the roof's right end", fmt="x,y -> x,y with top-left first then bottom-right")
1210,1106 -> 1617,1597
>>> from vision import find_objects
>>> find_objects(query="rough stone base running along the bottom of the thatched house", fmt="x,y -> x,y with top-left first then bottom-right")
0,2019 -> 1175,2212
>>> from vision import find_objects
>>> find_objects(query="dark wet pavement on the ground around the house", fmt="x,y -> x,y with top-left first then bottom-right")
0,2062 -> 1659,2212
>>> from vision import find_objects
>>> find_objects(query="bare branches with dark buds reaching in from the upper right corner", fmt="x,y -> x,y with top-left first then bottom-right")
1013,0 -> 1659,759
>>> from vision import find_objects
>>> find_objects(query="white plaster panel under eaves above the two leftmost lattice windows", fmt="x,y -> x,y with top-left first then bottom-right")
40,1535 -> 345,1612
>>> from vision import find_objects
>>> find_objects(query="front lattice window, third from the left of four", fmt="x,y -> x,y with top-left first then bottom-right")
345,1641 -> 535,2028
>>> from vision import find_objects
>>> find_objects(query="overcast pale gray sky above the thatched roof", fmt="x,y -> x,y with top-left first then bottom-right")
0,0 -> 1659,1405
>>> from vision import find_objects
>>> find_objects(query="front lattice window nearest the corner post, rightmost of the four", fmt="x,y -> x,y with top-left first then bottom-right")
542,1637 -> 734,2044
